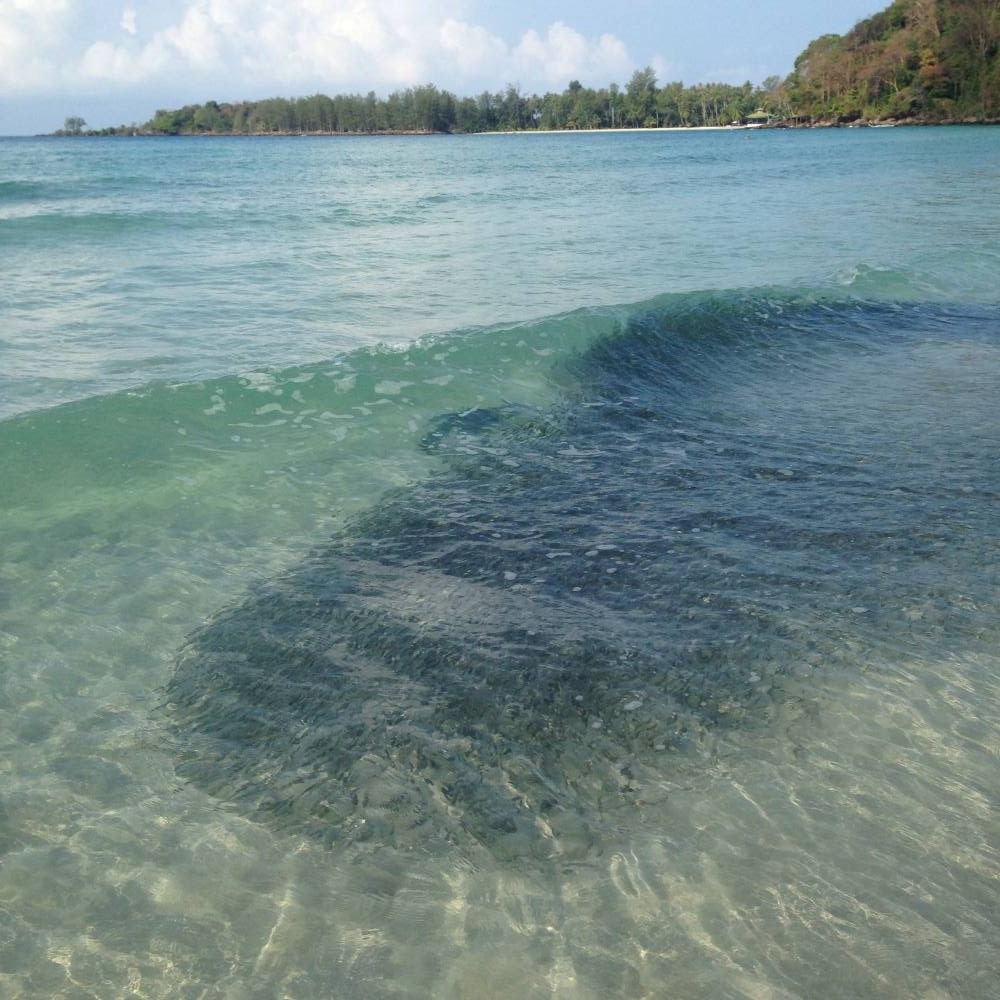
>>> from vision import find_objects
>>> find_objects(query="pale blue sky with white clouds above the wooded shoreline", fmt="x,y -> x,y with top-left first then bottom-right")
0,0 -> 888,135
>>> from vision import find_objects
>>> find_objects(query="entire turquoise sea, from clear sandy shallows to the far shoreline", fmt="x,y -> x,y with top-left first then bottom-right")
0,127 -> 1000,1000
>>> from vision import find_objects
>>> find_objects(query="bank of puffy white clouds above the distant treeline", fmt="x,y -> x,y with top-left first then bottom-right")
0,0 -> 635,98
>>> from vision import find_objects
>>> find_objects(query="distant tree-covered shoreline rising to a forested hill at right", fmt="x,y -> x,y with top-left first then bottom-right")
56,0 -> 1000,135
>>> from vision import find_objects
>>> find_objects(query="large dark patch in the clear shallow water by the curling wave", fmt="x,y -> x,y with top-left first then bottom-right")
164,292 -> 1000,860
